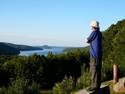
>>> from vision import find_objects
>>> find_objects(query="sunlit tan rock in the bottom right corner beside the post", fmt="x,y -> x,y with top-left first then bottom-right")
113,78 -> 125,93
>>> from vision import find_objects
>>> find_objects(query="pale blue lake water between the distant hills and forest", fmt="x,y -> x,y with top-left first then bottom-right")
19,47 -> 65,56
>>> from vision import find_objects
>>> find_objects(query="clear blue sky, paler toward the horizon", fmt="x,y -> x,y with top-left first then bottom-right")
0,0 -> 125,46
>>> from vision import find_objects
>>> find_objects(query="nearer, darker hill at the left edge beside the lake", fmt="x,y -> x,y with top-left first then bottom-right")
0,43 -> 20,55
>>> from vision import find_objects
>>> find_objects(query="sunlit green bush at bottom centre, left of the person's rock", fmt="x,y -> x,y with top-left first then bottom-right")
53,77 -> 74,94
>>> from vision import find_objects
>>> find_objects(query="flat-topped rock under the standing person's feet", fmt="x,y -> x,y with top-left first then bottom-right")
75,85 -> 110,94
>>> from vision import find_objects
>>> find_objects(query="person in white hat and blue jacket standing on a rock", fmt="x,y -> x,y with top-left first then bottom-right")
87,21 -> 102,91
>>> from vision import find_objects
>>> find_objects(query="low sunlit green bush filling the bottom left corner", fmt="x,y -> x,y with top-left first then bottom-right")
0,78 -> 40,94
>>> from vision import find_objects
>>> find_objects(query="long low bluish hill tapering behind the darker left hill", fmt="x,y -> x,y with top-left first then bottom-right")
0,42 -> 43,51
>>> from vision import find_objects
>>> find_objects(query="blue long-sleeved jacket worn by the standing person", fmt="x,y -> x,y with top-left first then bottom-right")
87,29 -> 102,58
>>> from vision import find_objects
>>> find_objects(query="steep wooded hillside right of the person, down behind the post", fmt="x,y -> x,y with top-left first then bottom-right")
103,20 -> 125,79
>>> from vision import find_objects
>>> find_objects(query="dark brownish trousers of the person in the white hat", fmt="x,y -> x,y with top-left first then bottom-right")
90,58 -> 102,89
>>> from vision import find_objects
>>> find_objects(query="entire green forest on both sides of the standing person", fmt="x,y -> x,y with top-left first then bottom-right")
0,20 -> 125,94
